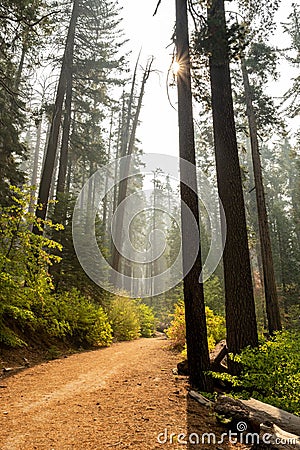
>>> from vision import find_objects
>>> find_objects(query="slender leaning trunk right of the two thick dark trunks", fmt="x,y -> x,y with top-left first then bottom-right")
241,59 -> 282,334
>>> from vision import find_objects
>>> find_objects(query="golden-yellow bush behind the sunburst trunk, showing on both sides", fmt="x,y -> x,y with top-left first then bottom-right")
166,300 -> 226,356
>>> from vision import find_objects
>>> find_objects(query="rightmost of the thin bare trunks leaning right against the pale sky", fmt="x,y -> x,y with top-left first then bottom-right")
112,59 -> 153,278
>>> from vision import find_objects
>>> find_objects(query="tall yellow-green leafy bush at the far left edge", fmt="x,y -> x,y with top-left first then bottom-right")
0,187 -> 61,347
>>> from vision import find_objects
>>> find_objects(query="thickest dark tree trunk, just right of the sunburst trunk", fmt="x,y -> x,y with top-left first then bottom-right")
208,0 -> 258,372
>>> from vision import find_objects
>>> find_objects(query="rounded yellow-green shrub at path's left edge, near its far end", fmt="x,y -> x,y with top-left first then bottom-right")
108,296 -> 140,341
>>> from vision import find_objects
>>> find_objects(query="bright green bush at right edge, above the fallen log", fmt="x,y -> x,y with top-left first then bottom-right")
214,331 -> 300,416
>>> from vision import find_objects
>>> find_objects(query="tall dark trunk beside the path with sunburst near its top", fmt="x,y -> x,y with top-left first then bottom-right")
176,0 -> 211,391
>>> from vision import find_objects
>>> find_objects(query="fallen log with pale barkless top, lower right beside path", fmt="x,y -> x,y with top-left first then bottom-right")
215,396 -> 300,436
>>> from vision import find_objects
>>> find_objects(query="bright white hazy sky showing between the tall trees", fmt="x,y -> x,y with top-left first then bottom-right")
119,0 -> 295,156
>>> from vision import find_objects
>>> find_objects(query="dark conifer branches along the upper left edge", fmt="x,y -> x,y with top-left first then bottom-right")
0,0 -> 50,205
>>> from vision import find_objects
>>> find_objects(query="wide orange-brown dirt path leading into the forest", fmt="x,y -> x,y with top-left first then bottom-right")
0,338 -> 248,450
